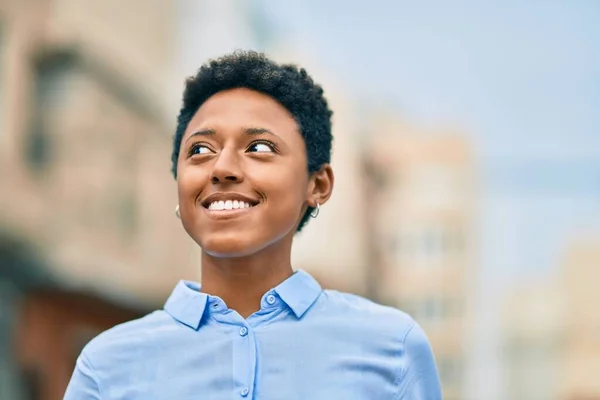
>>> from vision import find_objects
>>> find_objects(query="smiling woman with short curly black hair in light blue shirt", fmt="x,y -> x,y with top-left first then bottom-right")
65,52 -> 441,400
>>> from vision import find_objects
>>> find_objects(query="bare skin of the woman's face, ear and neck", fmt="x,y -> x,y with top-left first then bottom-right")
177,88 -> 334,318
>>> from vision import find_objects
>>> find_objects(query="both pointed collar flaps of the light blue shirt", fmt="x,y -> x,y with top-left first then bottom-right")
164,270 -> 321,329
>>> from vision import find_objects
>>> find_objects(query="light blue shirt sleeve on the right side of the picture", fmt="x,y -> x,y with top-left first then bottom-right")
396,323 -> 442,400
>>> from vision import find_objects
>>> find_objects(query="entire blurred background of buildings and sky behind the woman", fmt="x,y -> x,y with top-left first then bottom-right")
0,0 -> 600,400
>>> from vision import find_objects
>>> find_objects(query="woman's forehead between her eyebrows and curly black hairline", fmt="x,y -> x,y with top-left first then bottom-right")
188,88 -> 298,133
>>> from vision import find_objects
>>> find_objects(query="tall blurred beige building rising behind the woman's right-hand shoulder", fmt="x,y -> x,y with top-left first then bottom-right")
365,116 -> 476,400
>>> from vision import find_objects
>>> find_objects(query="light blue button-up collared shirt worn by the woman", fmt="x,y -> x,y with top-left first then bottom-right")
65,271 -> 442,400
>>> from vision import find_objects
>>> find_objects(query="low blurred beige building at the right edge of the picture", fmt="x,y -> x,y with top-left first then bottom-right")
503,237 -> 600,400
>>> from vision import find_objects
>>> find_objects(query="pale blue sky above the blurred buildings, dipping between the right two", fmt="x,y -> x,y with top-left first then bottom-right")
261,0 -> 600,276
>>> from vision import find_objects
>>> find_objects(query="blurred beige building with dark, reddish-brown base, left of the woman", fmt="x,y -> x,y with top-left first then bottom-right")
0,0 -> 198,400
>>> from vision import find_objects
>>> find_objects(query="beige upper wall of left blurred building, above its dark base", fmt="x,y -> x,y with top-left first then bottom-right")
0,0 -> 198,306
